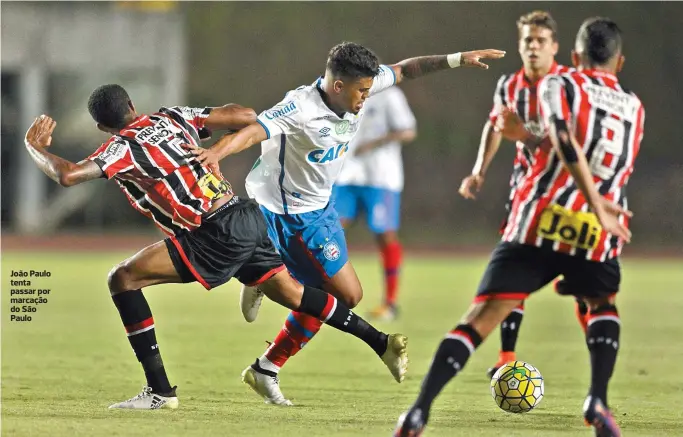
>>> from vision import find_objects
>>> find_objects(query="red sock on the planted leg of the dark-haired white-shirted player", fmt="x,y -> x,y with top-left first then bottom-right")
261,311 -> 323,372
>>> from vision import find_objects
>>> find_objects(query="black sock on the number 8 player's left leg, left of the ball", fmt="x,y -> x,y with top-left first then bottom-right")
415,325 -> 482,417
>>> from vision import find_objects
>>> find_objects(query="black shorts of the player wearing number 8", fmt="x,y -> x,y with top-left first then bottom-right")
475,241 -> 621,301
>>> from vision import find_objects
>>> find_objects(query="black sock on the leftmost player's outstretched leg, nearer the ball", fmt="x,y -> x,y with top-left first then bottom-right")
297,285 -> 388,356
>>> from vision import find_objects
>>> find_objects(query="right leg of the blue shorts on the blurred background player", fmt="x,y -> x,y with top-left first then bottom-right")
361,187 -> 401,234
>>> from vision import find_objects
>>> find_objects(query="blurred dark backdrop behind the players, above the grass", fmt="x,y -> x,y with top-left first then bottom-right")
1,1 -> 683,254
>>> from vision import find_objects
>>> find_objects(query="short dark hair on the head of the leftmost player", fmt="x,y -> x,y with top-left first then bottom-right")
88,85 -> 130,129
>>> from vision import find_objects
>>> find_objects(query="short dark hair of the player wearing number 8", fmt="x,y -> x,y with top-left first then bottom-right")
576,17 -> 622,65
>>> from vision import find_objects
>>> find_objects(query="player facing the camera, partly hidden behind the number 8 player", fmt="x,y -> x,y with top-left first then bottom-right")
459,11 -> 587,378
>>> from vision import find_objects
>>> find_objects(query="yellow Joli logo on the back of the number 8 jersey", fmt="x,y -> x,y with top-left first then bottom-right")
538,205 -> 602,249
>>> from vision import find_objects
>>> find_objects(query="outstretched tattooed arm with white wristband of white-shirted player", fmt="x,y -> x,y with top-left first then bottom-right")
390,49 -> 505,83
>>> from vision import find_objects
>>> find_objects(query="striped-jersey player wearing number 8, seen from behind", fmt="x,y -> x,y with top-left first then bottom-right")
395,17 -> 645,437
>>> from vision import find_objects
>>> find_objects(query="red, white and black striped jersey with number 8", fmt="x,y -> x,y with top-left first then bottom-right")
503,70 -> 645,261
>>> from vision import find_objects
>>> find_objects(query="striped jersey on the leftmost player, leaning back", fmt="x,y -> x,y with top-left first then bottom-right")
88,106 -> 231,235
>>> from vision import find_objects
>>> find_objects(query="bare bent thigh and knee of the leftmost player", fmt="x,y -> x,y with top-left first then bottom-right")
108,241 -> 183,293
